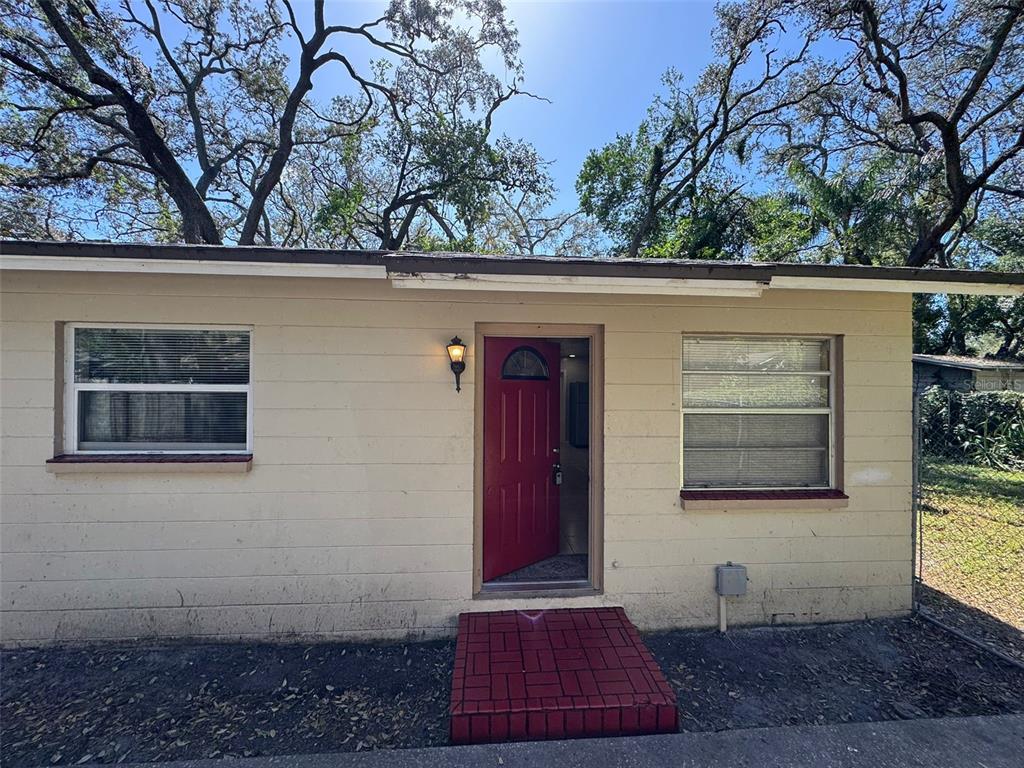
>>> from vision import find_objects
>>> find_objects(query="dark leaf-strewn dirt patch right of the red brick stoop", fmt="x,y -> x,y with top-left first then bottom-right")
644,618 -> 1024,731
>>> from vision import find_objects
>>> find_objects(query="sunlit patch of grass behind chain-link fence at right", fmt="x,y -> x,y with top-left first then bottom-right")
921,462 -> 1024,629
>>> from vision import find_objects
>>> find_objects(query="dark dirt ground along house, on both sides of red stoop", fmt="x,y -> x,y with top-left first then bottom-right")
0,618 -> 1024,768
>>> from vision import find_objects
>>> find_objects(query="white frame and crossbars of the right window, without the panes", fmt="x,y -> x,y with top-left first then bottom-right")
679,334 -> 839,492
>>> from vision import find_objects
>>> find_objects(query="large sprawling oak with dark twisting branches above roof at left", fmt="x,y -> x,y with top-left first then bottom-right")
0,0 -> 548,248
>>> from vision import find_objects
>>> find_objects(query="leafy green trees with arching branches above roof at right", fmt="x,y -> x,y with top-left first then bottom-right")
577,0 -> 1024,267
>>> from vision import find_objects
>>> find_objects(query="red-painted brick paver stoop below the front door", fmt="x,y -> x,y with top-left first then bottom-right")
449,608 -> 679,744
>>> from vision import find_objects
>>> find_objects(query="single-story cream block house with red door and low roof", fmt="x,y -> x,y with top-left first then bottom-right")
0,242 -> 1024,644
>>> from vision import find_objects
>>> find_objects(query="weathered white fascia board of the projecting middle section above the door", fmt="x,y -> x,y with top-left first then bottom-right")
391,272 -> 767,298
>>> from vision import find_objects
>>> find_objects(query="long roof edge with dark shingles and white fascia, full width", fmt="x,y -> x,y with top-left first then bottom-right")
0,241 -> 1024,298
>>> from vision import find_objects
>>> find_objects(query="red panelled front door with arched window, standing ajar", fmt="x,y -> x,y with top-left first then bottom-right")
483,338 -> 559,582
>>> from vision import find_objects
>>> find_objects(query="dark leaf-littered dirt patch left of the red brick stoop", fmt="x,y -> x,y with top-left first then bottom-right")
0,641 -> 455,768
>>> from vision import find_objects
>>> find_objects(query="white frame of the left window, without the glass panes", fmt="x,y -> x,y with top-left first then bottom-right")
63,323 -> 254,456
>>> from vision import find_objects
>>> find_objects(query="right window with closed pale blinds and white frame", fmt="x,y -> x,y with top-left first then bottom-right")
682,336 -> 835,489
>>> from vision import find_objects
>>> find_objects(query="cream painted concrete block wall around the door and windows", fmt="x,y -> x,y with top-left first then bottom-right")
0,272 -> 911,643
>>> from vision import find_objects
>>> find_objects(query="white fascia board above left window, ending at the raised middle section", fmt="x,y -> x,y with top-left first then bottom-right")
0,254 -> 387,280
